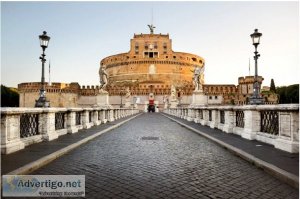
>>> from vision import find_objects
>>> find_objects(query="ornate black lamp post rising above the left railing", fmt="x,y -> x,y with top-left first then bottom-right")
35,31 -> 50,107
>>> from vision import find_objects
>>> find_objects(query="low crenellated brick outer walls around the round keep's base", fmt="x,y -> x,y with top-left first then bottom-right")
18,76 -> 278,107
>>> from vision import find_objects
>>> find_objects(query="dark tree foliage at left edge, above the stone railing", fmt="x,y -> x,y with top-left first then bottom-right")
1,84 -> 19,107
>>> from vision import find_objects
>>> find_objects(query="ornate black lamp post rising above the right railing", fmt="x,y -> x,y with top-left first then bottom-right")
249,29 -> 264,104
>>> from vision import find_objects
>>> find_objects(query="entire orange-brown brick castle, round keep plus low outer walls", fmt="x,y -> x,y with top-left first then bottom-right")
18,30 -> 278,107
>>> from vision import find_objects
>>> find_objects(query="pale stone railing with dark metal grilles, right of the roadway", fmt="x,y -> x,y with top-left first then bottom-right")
164,104 -> 299,153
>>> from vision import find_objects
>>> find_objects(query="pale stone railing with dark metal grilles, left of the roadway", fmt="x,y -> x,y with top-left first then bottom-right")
1,108 -> 139,154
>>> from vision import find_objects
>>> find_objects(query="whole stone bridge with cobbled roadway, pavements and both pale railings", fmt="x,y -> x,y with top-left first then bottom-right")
1,105 -> 299,198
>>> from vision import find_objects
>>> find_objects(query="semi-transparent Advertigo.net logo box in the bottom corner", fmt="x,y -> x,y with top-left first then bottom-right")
2,175 -> 85,197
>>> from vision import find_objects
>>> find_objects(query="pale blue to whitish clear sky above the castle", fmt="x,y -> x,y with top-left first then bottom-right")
1,1 -> 299,87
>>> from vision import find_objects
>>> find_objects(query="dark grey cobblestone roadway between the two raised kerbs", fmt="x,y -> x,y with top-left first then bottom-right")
34,113 -> 298,199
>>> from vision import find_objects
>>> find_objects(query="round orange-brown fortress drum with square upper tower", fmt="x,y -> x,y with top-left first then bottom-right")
100,34 -> 205,96
